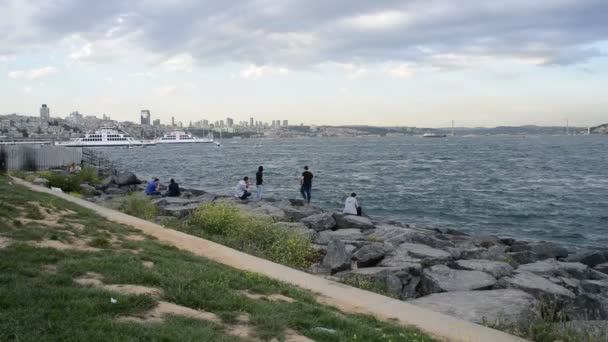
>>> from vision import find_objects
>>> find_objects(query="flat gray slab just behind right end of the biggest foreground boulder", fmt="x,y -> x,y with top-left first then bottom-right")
499,272 -> 575,298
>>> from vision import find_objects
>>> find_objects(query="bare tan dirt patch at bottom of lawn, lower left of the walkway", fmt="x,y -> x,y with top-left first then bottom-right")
118,301 -> 222,324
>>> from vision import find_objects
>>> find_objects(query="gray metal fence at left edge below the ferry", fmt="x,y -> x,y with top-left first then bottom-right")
0,145 -> 82,171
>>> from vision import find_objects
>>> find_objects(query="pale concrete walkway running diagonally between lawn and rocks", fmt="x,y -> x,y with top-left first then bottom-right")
13,178 -> 524,342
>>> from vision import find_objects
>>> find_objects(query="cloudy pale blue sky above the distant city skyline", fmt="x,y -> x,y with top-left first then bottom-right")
0,0 -> 608,127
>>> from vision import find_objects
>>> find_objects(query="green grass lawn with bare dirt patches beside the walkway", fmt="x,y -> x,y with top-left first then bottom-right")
0,176 -> 432,341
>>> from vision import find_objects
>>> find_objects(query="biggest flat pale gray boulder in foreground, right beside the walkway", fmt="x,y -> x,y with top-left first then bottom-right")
409,290 -> 537,327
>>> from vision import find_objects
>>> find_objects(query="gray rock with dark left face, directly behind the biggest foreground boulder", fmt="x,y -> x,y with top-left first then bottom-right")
421,265 -> 496,295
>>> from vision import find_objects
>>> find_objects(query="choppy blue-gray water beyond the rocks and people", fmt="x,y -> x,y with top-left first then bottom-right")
108,136 -> 608,247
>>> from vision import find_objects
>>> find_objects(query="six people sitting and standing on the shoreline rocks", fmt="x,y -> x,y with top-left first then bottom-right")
145,166 -> 362,216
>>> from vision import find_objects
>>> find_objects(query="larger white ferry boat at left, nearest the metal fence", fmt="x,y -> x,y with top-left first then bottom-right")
55,127 -> 154,147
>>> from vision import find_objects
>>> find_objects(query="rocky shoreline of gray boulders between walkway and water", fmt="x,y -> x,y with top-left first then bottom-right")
52,173 -> 608,327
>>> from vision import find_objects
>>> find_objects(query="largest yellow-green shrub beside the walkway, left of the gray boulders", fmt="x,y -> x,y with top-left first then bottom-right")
188,204 -> 316,268
